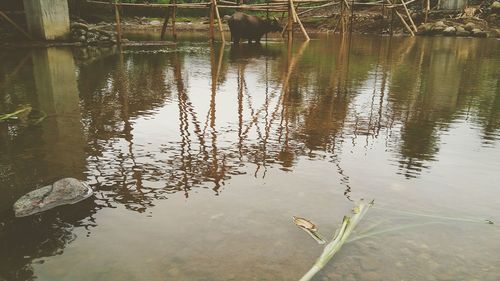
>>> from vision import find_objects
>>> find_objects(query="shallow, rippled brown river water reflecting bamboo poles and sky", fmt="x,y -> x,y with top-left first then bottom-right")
0,34 -> 500,281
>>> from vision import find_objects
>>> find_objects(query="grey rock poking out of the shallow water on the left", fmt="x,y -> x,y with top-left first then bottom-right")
14,178 -> 93,217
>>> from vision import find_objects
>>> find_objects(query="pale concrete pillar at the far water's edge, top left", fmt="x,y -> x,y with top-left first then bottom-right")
23,0 -> 70,40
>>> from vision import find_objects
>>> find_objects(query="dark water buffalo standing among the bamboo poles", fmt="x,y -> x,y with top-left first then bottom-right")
227,12 -> 281,44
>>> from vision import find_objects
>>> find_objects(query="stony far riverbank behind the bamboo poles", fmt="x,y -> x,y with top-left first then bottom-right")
0,1 -> 500,46
